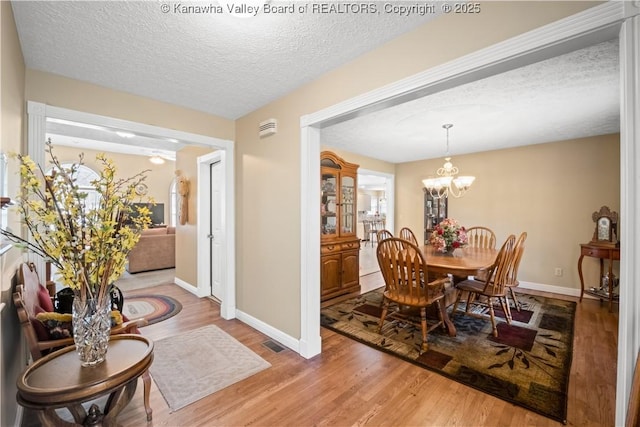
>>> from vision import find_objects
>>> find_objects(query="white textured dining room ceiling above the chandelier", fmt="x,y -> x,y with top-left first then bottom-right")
322,40 -> 620,163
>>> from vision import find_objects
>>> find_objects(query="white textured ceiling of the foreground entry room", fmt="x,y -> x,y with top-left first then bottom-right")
12,1 -> 435,119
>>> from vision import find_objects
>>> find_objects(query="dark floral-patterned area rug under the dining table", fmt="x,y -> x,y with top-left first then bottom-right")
321,289 -> 576,423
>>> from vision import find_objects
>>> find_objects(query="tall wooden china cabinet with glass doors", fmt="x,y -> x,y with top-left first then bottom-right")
320,151 -> 360,301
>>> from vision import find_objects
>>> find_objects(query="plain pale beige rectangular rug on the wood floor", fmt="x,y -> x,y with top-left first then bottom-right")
150,325 -> 271,412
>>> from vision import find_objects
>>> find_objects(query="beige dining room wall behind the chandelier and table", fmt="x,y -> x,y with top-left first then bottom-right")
396,134 -> 620,289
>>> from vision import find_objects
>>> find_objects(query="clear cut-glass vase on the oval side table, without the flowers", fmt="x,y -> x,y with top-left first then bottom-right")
72,294 -> 111,366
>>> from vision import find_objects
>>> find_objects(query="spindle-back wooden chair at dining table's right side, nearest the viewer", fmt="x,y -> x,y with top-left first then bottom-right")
451,234 -> 516,337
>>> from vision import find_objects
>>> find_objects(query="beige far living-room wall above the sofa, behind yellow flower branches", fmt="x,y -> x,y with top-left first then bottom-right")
52,145 -> 176,224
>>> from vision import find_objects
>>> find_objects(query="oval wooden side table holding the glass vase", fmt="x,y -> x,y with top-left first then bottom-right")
17,334 -> 153,427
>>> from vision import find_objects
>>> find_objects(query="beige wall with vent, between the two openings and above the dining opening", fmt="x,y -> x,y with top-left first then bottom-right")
236,2 -> 597,337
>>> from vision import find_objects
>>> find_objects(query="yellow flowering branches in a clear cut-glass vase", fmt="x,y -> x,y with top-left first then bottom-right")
0,140 -> 151,366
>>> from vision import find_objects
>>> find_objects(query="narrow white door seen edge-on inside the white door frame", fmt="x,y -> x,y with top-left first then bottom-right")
209,161 -> 223,300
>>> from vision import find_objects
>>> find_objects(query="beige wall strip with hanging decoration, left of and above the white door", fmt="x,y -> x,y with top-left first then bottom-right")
176,147 -> 214,286
